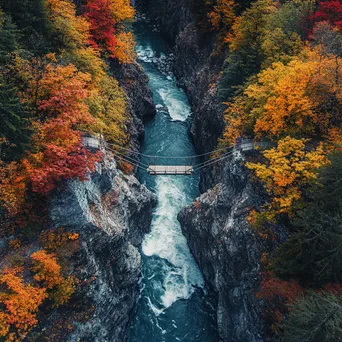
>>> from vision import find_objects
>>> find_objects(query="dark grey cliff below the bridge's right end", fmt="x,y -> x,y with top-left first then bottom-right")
178,152 -> 263,342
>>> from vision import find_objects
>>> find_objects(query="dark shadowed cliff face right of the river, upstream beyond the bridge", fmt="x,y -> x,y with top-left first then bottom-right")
136,0 -> 224,153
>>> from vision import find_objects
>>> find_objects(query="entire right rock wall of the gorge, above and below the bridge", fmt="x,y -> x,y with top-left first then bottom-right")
138,0 -> 264,341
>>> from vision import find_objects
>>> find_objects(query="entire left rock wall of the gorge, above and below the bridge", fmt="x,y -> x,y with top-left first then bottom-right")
31,63 -> 156,342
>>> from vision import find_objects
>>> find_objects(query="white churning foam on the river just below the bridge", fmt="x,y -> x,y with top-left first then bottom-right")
142,176 -> 204,308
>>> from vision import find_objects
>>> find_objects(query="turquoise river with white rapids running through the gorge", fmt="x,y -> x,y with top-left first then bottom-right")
129,9 -> 219,342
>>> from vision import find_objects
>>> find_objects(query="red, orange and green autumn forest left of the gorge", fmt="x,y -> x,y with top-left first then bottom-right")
0,0 -> 135,341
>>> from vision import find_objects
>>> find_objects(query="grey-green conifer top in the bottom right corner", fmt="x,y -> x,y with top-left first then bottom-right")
282,292 -> 342,342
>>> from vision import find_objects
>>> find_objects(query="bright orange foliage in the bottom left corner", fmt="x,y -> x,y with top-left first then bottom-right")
0,268 -> 46,341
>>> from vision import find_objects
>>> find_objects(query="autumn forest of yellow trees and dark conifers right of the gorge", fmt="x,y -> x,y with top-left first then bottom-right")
204,0 -> 342,341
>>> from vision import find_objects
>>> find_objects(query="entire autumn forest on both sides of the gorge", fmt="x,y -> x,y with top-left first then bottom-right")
0,0 -> 342,342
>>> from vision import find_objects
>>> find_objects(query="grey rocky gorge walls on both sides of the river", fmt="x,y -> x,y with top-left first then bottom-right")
36,0 -> 264,342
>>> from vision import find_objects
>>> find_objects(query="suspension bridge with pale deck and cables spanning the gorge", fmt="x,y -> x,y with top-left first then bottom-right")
83,136 -> 271,176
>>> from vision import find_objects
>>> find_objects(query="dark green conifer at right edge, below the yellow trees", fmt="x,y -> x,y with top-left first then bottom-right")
272,153 -> 342,285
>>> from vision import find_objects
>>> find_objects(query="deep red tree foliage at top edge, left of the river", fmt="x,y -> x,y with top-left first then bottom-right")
84,0 -> 116,54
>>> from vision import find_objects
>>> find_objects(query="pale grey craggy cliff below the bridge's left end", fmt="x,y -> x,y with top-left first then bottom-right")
50,155 -> 156,341
